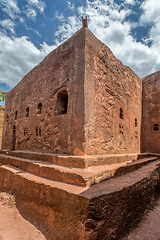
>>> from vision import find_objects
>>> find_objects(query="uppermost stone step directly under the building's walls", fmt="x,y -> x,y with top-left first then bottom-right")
0,150 -> 152,168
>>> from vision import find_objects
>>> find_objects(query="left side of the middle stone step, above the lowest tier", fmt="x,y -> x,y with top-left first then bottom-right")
0,154 -> 86,186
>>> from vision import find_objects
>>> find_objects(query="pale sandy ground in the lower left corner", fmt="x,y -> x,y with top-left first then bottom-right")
0,192 -> 46,240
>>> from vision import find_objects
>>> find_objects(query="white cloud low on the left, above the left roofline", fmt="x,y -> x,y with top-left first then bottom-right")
0,34 -> 55,87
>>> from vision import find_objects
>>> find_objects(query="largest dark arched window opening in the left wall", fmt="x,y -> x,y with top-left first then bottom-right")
55,90 -> 68,115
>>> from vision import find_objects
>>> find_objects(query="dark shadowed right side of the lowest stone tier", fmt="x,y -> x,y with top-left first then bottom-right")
80,160 -> 160,240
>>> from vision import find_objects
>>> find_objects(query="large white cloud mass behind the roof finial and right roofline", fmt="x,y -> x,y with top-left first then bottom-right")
53,0 -> 160,77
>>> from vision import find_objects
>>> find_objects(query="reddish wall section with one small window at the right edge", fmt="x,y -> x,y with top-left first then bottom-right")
142,71 -> 160,153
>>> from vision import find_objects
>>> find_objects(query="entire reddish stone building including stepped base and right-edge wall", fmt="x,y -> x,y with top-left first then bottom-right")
0,20 -> 160,240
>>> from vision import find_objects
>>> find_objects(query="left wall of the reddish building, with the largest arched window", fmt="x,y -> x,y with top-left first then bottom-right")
3,29 -> 85,154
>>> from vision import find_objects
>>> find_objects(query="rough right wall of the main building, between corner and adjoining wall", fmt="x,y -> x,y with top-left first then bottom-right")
85,28 -> 142,154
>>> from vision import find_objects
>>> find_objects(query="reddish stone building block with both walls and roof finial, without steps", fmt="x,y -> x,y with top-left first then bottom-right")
2,20 -> 142,155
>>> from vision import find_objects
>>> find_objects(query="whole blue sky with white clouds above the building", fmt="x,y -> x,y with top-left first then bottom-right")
0,0 -> 160,91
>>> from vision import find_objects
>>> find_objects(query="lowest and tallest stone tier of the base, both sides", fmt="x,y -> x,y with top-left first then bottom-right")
0,160 -> 160,240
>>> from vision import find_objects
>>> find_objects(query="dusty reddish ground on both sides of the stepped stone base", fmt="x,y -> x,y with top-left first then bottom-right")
0,193 -> 160,240
